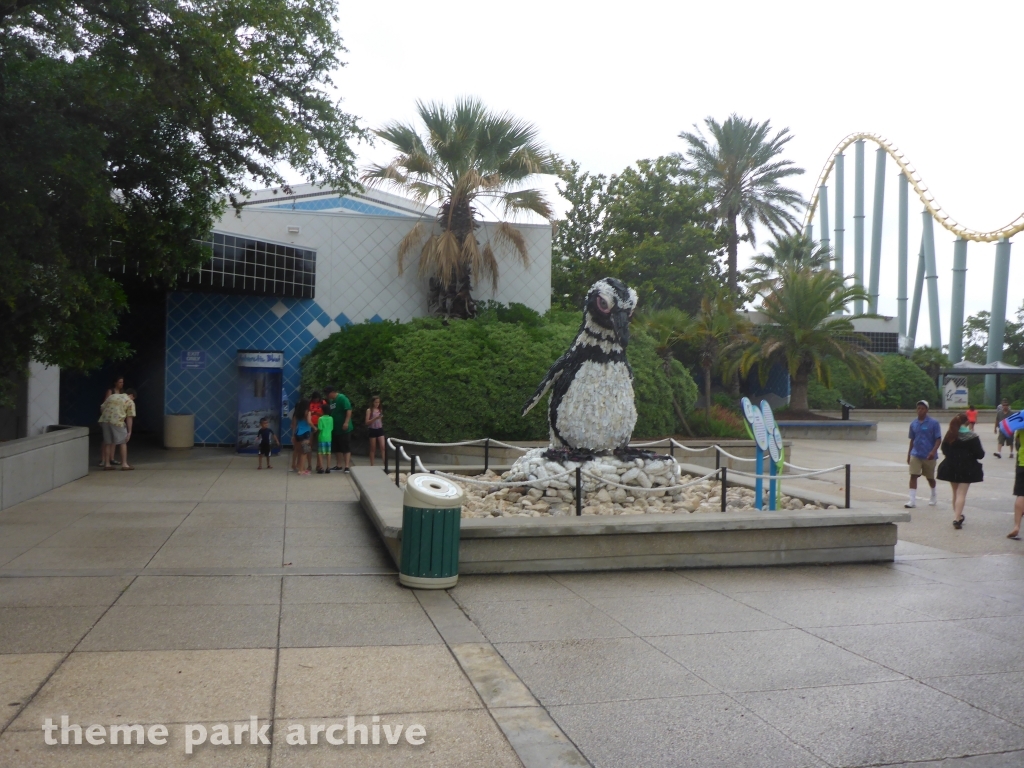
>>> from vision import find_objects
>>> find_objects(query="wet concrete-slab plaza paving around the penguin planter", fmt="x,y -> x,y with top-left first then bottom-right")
0,430 -> 1024,768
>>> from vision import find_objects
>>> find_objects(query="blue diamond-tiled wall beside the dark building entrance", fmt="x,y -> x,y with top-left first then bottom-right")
164,293 -> 321,444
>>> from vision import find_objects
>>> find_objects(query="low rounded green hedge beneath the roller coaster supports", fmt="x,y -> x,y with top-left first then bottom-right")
807,354 -> 939,411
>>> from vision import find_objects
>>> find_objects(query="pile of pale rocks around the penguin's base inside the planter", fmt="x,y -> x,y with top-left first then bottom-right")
395,449 -> 836,518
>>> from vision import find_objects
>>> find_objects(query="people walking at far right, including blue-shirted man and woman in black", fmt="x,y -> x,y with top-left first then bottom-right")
903,398 -> 1024,541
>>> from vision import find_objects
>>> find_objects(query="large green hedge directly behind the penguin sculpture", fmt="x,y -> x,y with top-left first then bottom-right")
302,305 -> 697,442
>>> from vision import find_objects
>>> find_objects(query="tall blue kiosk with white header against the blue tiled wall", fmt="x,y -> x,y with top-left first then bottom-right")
237,349 -> 285,456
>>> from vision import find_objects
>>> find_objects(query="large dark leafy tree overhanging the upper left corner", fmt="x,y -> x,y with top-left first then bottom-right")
0,0 -> 360,405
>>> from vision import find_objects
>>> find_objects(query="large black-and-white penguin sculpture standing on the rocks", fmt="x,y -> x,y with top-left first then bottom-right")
522,278 -> 637,453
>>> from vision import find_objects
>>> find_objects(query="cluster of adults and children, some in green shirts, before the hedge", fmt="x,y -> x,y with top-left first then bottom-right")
284,387 -> 384,475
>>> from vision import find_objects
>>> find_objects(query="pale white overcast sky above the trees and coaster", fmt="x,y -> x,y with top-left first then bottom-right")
321,0 -> 1024,344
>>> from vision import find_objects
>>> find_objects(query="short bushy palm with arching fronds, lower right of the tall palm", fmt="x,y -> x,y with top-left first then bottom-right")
739,268 -> 885,411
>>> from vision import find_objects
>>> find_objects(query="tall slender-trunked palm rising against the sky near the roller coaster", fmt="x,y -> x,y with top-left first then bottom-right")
679,113 -> 804,294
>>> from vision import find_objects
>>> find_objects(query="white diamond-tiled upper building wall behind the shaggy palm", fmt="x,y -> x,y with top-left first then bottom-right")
215,207 -> 551,338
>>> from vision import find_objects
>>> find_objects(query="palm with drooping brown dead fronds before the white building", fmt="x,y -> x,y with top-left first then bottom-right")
362,98 -> 555,317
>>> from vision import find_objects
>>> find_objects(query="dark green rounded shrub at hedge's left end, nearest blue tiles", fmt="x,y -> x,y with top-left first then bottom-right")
302,321 -> 410,413
